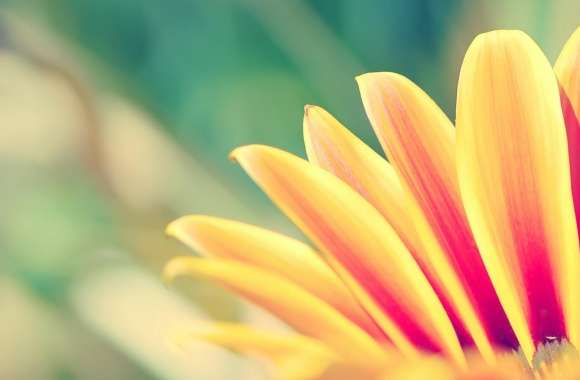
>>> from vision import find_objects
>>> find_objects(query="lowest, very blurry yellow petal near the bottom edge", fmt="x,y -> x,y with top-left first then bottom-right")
176,323 -> 339,380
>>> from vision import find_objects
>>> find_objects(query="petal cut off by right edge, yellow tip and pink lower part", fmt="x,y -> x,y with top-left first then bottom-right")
554,28 -> 580,235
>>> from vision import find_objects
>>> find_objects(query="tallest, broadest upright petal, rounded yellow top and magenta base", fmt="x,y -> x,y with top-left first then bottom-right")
457,31 -> 580,358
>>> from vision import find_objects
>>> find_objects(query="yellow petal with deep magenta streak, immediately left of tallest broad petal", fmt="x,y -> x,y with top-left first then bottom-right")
357,73 -> 515,351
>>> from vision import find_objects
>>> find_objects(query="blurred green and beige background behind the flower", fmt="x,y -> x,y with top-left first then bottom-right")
0,0 -> 580,380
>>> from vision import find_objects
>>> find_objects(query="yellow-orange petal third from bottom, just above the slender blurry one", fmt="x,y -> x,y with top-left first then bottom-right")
167,215 -> 385,339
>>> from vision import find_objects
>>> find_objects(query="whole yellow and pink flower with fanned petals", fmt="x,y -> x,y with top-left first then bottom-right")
165,29 -> 580,379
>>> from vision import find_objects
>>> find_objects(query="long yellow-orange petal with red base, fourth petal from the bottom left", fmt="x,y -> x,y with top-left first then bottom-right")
232,145 -> 464,363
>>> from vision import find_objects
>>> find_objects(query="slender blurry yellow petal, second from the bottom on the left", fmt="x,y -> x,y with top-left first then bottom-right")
164,257 -> 385,368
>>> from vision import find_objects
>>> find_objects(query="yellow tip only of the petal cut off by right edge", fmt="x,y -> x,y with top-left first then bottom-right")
554,27 -> 580,119
